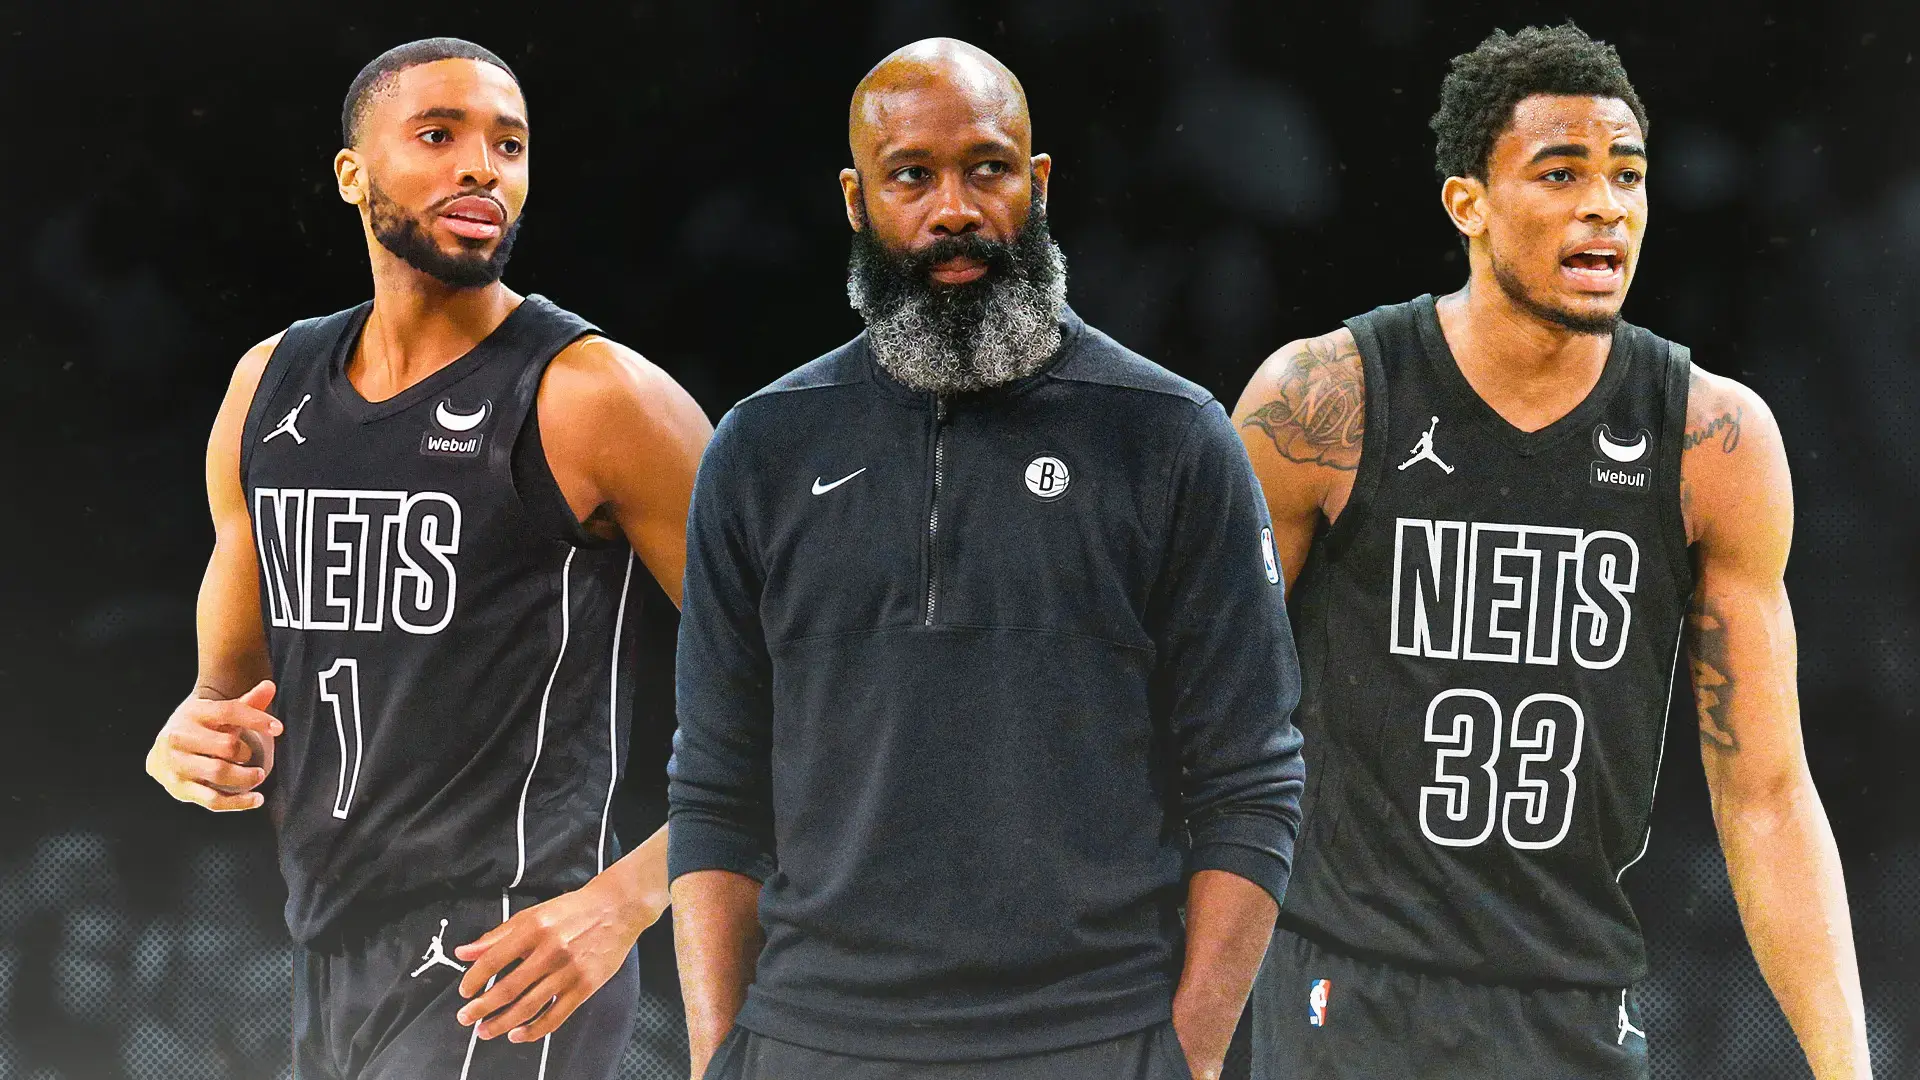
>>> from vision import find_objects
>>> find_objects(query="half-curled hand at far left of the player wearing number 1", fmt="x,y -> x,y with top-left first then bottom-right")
146,680 -> 286,811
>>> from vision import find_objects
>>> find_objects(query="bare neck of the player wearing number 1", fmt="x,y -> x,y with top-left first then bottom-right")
348,259 -> 522,402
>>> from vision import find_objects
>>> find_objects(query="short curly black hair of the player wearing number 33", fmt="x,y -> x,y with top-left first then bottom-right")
1428,19 -> 1647,181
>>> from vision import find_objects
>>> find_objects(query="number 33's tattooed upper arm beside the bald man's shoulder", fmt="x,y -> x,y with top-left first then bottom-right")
1233,329 -> 1367,586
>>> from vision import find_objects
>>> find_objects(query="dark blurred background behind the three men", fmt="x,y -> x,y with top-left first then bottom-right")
0,0 -> 1920,1080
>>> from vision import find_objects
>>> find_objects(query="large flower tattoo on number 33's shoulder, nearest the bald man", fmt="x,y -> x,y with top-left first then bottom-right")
1240,340 -> 1367,471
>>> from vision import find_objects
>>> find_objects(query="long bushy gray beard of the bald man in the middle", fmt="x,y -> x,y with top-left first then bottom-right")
847,238 -> 1068,394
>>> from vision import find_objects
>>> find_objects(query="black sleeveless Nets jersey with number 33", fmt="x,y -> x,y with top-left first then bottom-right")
1281,296 -> 1693,986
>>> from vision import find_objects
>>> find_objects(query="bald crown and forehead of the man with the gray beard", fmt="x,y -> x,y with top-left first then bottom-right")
847,38 -> 1033,161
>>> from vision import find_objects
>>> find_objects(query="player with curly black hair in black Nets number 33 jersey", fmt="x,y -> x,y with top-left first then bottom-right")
1235,23 -> 1868,1078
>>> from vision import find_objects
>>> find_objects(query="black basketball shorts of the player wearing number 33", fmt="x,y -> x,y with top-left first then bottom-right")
1250,928 -> 1647,1080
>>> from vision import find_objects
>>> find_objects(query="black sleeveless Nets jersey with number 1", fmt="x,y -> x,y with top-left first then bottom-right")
240,296 -> 636,942
